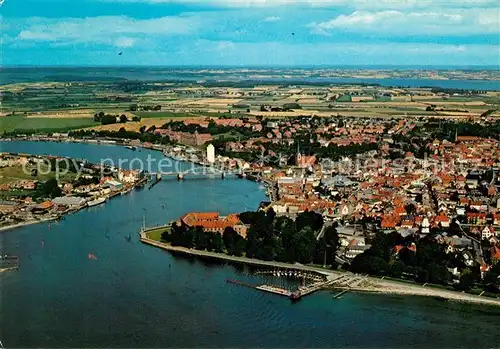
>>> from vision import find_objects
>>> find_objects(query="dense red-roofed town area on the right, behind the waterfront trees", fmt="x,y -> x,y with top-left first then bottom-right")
323,137 -> 500,270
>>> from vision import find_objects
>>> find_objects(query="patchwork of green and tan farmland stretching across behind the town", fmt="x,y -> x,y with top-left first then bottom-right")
0,76 -> 500,133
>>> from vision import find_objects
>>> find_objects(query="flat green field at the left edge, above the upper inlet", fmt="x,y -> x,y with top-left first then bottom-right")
0,115 -> 99,133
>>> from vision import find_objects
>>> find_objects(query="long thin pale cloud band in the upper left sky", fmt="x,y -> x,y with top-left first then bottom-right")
17,16 -> 200,47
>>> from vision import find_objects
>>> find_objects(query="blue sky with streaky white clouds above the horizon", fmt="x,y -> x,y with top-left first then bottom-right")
0,0 -> 500,66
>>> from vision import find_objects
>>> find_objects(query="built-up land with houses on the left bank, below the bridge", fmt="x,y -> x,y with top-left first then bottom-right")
0,154 -> 142,225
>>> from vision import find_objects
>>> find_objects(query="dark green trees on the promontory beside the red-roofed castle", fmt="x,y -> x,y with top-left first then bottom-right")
161,209 -> 339,265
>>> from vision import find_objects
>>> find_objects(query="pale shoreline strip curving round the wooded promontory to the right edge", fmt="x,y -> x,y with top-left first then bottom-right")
140,230 -> 500,306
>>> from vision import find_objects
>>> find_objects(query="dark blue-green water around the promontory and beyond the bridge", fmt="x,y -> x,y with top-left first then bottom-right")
0,142 -> 500,348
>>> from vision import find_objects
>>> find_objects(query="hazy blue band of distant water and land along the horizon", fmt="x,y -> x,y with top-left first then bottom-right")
0,67 -> 500,90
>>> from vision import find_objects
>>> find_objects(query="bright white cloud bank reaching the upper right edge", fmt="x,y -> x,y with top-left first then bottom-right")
308,9 -> 500,36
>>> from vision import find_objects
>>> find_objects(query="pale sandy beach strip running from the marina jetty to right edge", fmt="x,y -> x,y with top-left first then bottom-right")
336,277 -> 500,306
